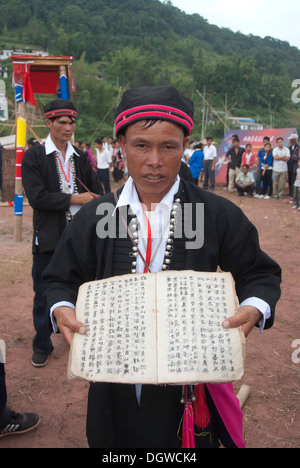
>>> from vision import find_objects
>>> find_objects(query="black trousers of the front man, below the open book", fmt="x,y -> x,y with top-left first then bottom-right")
87,383 -> 219,449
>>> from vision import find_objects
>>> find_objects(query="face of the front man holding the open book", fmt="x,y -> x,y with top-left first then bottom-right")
119,121 -> 189,203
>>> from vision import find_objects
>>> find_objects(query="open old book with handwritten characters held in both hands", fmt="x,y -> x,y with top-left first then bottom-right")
68,271 -> 244,385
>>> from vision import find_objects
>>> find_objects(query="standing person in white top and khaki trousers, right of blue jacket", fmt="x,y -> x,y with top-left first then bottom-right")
273,137 -> 290,199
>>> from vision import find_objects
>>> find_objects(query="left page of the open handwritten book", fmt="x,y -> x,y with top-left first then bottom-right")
68,274 -> 157,384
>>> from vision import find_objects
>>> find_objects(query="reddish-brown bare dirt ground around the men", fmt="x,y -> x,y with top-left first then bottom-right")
0,187 -> 300,448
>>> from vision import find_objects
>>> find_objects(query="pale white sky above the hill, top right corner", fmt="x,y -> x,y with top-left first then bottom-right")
171,0 -> 300,49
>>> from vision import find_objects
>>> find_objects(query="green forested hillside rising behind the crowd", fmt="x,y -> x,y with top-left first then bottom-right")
0,0 -> 300,139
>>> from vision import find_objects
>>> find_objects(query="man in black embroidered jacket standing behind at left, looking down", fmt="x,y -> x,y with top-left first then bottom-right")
22,99 -> 102,367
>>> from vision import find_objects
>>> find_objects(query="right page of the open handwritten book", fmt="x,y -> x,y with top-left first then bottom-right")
157,271 -> 244,384
